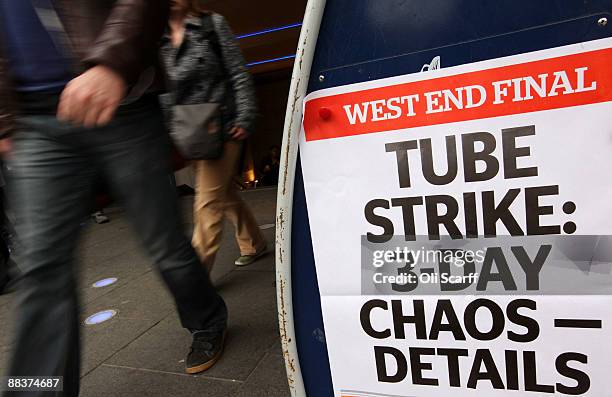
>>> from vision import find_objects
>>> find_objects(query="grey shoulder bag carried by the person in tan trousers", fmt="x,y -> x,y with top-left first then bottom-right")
170,15 -> 225,160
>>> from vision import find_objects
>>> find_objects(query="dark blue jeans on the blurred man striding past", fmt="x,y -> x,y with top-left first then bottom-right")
2,100 -> 227,397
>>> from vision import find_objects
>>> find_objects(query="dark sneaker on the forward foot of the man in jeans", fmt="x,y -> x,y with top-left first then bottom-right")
185,330 -> 226,374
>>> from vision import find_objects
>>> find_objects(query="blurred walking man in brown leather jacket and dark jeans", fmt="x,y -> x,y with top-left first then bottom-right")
0,0 -> 227,396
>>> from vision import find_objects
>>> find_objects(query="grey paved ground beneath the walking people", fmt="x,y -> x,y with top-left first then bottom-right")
0,189 -> 289,397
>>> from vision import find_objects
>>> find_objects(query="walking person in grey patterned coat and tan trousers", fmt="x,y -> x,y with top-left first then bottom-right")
161,0 -> 266,270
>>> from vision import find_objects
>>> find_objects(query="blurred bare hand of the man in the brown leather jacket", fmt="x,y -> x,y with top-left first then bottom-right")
57,66 -> 127,128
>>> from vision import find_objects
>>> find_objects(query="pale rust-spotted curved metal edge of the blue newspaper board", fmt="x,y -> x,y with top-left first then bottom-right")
276,0 -> 326,397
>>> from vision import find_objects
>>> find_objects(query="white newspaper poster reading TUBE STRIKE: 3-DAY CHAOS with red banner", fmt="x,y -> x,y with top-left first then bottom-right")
300,39 -> 612,397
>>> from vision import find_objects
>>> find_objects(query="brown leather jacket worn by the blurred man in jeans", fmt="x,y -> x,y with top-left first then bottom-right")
0,0 -> 169,138
